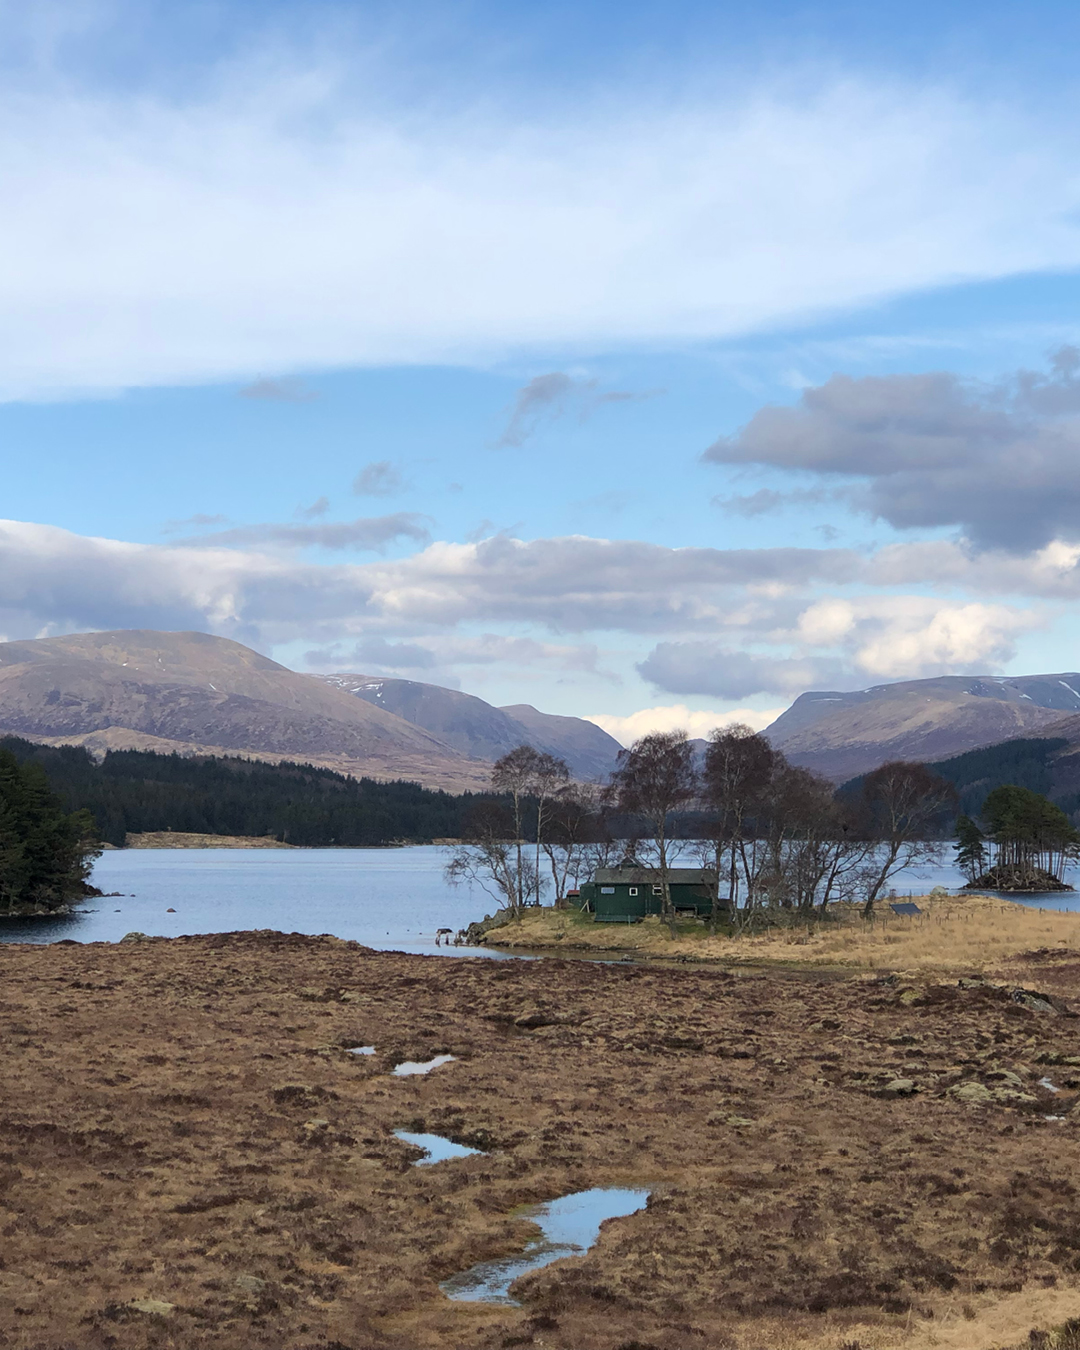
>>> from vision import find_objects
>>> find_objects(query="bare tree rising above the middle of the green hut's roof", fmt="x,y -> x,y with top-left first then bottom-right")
609,732 -> 699,937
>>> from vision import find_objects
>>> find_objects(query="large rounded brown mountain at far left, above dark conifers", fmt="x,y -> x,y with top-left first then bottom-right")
0,630 -> 483,791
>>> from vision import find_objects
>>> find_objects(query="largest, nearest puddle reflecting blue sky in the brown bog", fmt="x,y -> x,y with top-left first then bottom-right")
439,1187 -> 649,1307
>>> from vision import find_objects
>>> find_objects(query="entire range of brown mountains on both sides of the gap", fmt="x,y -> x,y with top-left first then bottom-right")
0,630 -> 1080,792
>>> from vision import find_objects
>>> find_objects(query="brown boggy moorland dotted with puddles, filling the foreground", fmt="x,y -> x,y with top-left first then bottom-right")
0,933 -> 1080,1350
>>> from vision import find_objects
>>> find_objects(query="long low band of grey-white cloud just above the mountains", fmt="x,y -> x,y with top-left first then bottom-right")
0,521 -> 1053,699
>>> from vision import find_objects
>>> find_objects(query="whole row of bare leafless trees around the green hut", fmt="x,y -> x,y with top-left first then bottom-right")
447,725 -> 956,926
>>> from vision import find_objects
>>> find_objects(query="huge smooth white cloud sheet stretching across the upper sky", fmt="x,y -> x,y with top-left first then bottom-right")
0,60 -> 1080,396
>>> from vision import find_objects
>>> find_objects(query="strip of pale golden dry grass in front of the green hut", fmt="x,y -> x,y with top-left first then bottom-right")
489,895 -> 1080,973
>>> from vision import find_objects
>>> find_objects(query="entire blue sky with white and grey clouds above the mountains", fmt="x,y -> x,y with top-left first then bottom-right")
0,0 -> 1080,741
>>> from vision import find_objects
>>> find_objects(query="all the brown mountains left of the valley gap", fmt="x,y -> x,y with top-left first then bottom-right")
0,630 -> 621,792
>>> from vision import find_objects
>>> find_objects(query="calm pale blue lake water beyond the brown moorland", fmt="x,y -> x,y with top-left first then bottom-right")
0,845 -> 1080,957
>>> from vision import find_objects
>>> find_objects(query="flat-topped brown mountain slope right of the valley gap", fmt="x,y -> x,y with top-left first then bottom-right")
765,674 -> 1080,782
